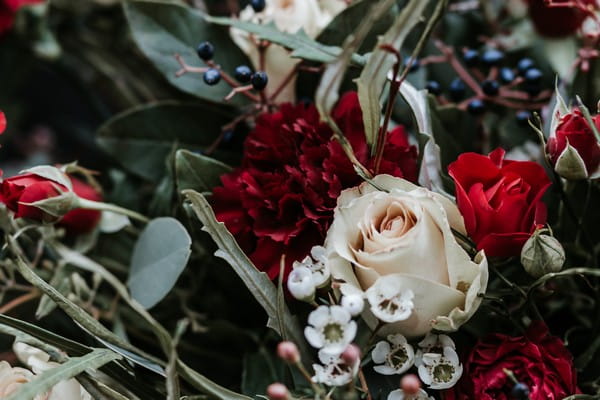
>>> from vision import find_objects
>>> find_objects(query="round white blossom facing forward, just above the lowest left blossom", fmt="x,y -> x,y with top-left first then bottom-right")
304,306 -> 356,354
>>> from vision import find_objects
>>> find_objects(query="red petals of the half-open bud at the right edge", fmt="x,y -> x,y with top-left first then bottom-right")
547,109 -> 600,178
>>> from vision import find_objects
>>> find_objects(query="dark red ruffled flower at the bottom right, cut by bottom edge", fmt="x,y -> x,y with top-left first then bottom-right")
444,322 -> 580,400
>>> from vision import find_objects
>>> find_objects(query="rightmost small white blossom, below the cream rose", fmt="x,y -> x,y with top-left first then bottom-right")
415,334 -> 463,390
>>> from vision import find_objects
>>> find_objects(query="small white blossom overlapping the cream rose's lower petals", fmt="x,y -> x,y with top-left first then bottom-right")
366,276 -> 414,323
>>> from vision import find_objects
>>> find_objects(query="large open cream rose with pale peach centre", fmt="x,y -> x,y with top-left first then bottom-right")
325,175 -> 488,337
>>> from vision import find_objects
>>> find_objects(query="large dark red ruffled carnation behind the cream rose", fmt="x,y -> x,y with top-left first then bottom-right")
212,92 -> 417,278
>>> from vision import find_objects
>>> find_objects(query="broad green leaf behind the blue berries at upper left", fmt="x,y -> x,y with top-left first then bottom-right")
123,1 -> 249,105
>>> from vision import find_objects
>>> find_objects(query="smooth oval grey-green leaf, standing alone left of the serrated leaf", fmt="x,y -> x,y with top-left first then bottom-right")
127,217 -> 192,309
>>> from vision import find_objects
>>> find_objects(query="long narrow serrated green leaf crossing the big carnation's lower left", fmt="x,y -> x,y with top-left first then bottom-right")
183,190 -> 308,361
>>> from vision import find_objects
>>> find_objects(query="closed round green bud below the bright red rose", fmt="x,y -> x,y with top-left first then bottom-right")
521,230 -> 565,278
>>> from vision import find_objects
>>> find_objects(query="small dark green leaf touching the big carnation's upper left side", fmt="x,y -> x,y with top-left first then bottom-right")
175,150 -> 231,192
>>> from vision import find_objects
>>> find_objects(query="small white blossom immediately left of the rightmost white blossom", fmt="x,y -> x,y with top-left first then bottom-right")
371,333 -> 415,375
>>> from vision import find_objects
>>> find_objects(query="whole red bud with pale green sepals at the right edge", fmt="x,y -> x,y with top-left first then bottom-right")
546,109 -> 600,180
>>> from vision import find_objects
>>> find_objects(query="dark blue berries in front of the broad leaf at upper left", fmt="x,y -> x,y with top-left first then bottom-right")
196,41 -> 269,91
